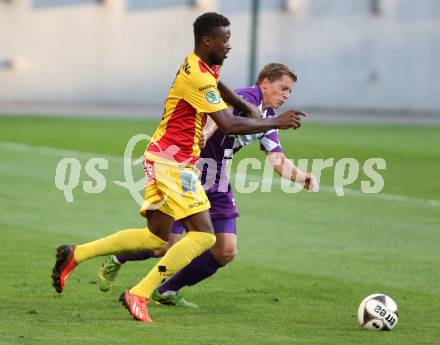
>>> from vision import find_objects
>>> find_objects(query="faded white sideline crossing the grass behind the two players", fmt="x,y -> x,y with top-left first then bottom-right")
0,141 -> 440,206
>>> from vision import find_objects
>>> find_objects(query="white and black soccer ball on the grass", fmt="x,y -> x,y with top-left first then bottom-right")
358,293 -> 399,331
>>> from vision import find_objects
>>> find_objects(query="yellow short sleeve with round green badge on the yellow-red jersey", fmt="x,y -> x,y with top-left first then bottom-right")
185,76 -> 227,113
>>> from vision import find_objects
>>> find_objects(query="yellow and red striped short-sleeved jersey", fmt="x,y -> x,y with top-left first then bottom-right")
146,52 -> 227,164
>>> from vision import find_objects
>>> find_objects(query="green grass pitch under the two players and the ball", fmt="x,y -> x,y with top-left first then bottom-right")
0,117 -> 440,345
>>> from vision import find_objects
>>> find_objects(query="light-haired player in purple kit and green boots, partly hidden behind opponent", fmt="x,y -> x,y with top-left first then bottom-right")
98,63 -> 317,307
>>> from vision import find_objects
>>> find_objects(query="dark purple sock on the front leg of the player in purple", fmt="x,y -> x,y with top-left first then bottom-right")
158,250 -> 223,293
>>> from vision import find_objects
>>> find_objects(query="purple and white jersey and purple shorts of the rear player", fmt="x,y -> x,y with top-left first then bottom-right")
199,85 -> 282,219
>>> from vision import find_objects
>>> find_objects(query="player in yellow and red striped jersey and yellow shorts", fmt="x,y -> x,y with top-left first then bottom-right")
52,13 -> 304,322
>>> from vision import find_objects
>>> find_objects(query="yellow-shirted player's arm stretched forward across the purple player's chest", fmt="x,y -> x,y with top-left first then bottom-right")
208,109 -> 305,134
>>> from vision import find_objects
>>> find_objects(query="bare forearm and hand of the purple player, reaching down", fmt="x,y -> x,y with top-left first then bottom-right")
266,152 -> 318,192
